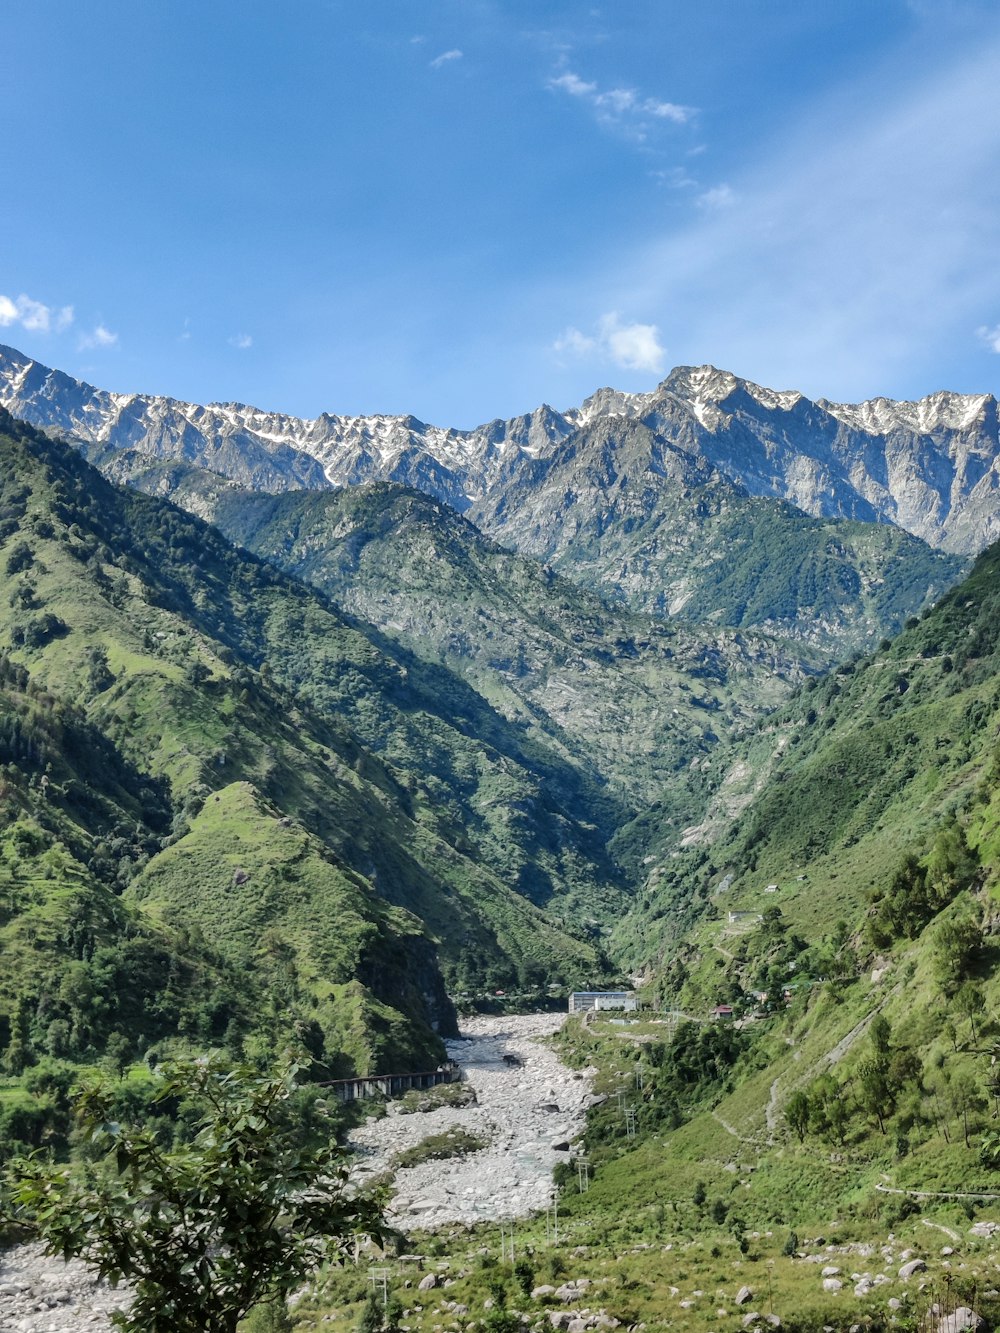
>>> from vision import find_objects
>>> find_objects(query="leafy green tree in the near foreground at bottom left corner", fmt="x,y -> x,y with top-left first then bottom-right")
8,1054 -> 380,1333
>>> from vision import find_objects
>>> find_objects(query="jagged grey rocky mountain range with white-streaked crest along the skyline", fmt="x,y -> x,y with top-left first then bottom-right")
0,347 -> 1000,555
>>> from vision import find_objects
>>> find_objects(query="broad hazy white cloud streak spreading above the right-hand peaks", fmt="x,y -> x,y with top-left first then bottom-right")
602,31 -> 1000,397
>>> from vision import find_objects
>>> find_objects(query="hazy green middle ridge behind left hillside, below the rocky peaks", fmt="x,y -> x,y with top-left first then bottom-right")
94,452 -> 819,802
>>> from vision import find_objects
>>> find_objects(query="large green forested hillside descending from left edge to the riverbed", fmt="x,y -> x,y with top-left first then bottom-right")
0,407 -> 621,1135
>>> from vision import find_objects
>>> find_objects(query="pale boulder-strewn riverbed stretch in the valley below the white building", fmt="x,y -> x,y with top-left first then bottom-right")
351,1014 -> 591,1230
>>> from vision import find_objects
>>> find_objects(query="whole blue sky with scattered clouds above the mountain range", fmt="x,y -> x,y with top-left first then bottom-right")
0,0 -> 1000,427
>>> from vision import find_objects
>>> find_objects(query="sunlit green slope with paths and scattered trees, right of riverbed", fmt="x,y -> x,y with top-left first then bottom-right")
469,547 -> 1000,1329
